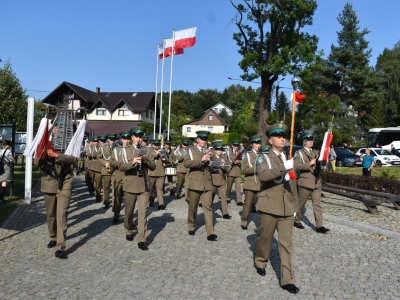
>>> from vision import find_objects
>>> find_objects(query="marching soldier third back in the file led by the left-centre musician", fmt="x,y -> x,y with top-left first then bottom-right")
96,135 -> 114,209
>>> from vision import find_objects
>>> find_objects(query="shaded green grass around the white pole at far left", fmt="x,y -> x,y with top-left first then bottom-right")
0,165 -> 42,224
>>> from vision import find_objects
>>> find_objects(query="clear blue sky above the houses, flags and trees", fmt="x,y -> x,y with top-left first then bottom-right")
0,0 -> 400,100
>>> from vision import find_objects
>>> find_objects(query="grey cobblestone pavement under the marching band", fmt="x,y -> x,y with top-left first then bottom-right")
0,176 -> 400,299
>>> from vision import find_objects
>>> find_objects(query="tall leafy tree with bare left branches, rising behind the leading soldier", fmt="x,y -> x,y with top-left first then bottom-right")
230,0 -> 318,143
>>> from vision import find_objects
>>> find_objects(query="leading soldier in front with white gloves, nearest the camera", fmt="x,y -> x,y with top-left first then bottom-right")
255,123 -> 299,294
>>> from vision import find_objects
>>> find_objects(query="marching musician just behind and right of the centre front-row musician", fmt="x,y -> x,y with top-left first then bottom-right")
211,144 -> 232,220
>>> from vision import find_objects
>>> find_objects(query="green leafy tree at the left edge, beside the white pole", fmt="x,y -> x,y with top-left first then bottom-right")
0,61 -> 27,131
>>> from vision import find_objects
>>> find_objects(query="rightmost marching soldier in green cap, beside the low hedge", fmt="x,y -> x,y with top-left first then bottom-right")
294,132 -> 330,234
